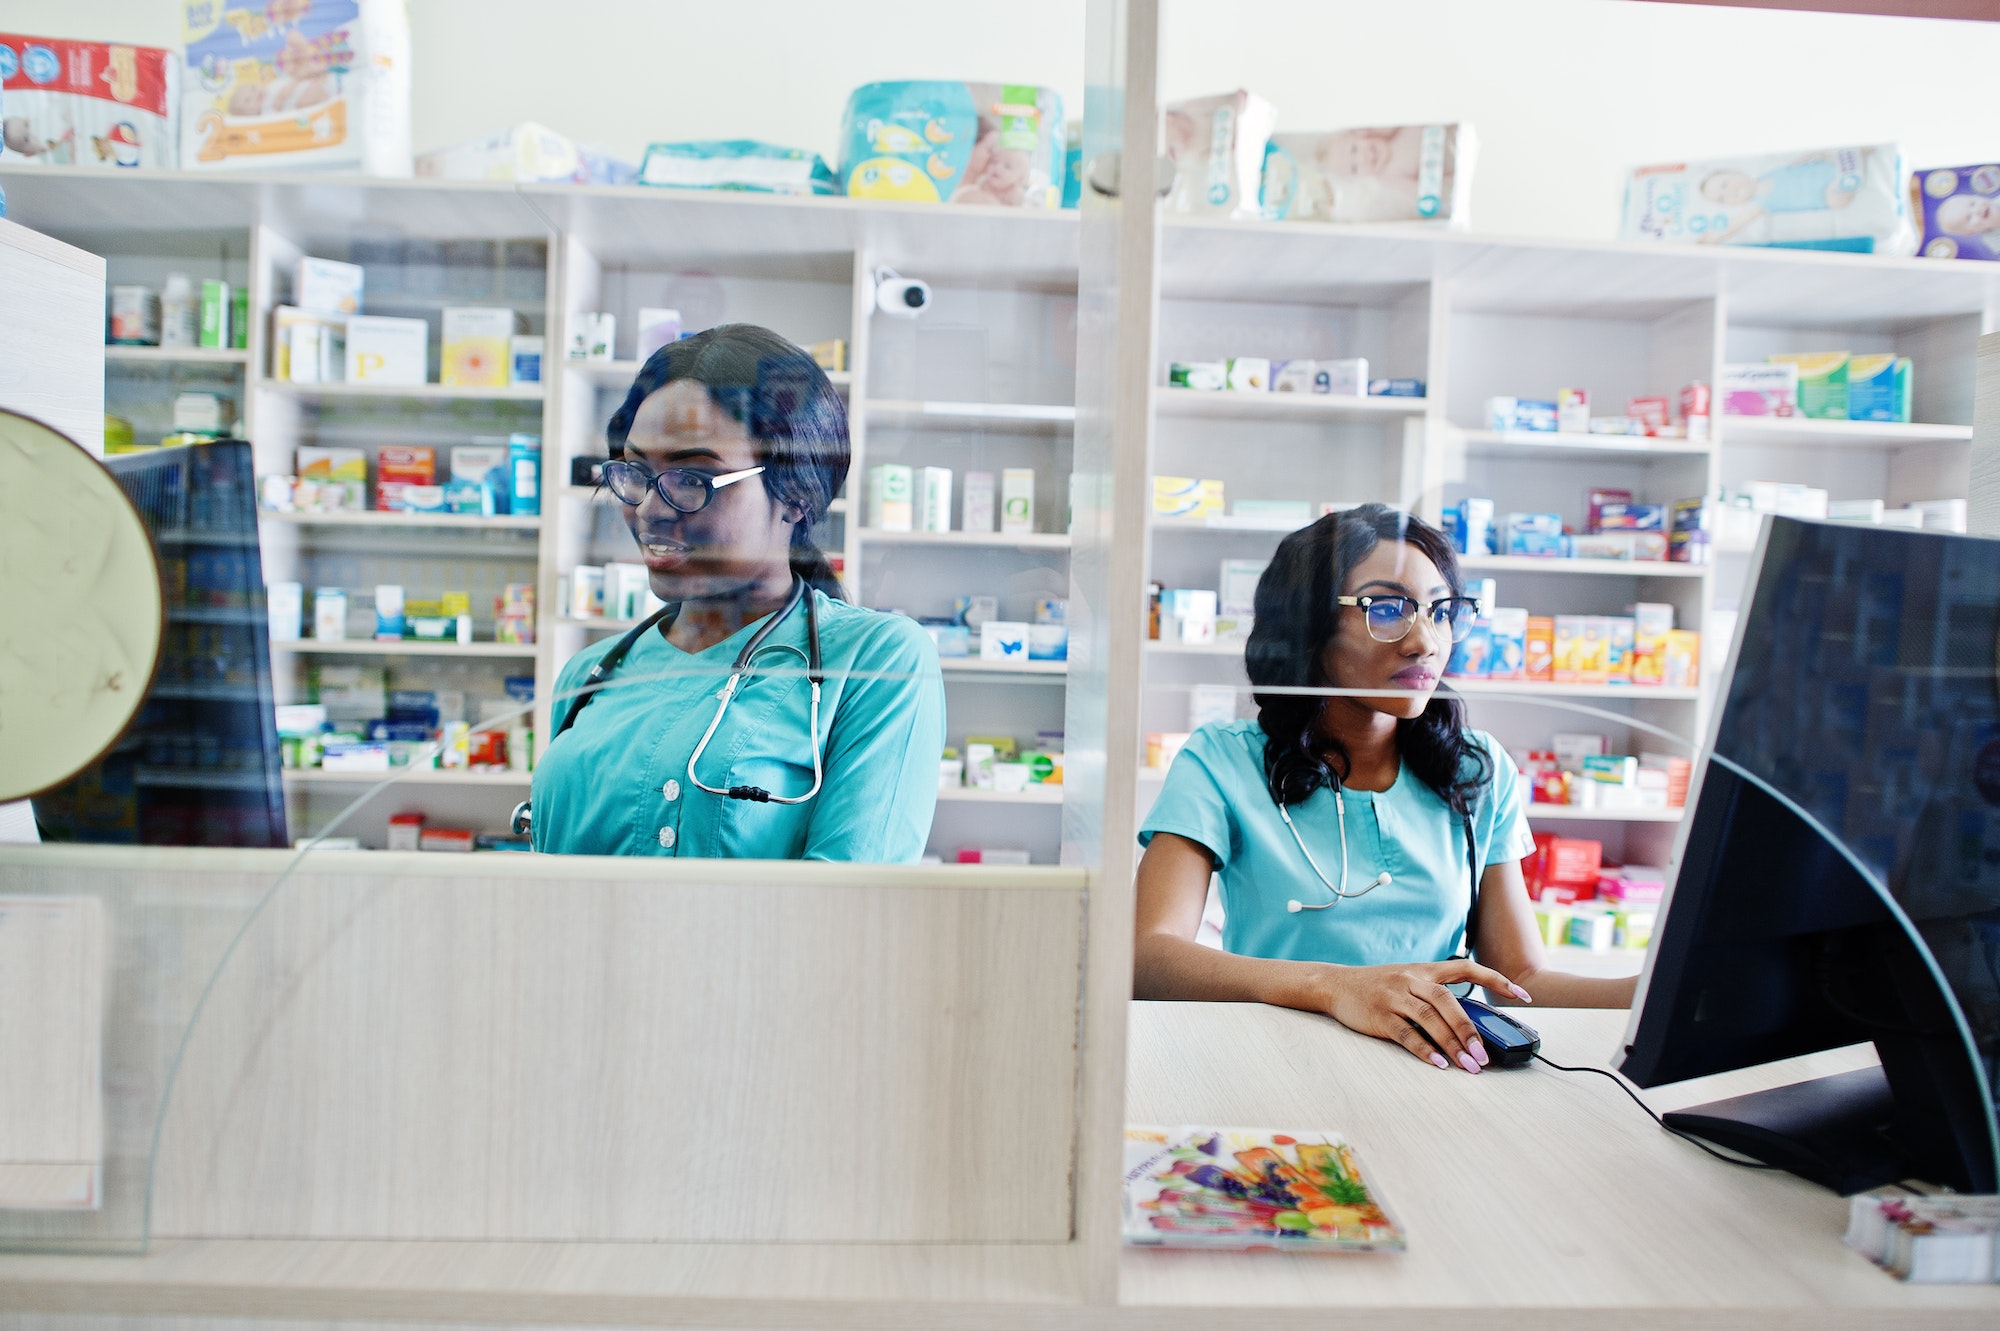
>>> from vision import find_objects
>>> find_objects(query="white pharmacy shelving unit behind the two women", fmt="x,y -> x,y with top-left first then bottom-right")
0,166 -> 2000,861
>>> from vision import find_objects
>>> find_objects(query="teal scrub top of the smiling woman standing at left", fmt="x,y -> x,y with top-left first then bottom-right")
532,592 -> 944,863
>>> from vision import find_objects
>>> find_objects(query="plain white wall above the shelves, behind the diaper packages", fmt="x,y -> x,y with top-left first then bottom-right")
15,0 -> 2000,238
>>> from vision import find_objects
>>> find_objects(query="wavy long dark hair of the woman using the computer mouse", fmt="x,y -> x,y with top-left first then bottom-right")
1244,504 -> 1492,815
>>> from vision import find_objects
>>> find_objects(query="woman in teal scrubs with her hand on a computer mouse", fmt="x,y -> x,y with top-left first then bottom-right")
1134,504 -> 1636,1073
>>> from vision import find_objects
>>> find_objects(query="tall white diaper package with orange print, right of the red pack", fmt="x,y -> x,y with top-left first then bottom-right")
180,0 -> 410,176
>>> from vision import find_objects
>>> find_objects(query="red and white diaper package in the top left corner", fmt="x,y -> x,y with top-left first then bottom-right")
0,32 -> 180,170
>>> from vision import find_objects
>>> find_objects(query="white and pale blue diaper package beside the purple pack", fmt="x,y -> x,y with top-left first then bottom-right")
1618,144 -> 1916,254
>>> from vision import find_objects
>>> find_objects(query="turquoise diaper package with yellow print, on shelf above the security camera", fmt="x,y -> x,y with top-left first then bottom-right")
840,80 -> 1068,208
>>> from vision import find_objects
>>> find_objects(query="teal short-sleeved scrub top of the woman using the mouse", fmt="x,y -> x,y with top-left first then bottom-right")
1138,721 -> 1534,965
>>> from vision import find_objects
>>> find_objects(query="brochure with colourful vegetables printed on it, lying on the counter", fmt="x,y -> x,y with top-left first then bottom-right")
1124,1125 -> 1404,1253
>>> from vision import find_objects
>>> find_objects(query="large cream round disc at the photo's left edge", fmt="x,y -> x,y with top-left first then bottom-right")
0,412 -> 166,801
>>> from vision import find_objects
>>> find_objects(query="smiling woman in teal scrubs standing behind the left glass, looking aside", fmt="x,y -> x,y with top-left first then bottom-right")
530,324 -> 944,861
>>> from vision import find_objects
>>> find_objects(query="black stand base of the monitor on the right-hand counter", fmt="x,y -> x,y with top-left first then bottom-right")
1662,1067 -> 1912,1197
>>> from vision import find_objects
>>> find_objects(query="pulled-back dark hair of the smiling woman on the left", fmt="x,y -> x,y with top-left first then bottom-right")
604,324 -> 852,600
